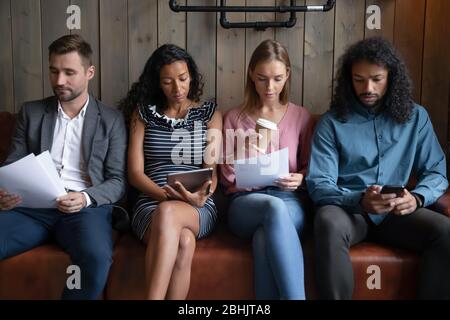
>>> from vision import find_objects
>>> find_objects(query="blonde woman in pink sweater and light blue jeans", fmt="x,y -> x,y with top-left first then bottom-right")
221,40 -> 312,300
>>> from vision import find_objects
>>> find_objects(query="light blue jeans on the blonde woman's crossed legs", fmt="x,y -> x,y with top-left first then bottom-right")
228,187 -> 305,300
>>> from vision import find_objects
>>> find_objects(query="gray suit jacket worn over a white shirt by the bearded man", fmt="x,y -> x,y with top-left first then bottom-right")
5,96 -> 127,206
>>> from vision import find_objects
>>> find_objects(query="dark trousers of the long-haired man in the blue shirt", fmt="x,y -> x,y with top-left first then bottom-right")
314,206 -> 450,299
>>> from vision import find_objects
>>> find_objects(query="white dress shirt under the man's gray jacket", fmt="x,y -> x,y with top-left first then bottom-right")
50,97 -> 92,207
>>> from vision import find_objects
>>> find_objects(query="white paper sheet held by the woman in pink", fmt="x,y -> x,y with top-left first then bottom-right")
234,148 -> 289,189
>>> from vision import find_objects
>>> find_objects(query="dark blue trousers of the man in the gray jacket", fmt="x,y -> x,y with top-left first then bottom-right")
0,206 -> 113,299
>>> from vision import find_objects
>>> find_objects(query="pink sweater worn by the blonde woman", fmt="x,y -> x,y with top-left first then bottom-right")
220,102 -> 314,193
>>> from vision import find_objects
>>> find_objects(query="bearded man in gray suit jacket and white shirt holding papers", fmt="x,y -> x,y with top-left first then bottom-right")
0,35 -> 127,299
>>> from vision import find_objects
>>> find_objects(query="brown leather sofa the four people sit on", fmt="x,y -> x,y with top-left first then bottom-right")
0,112 -> 450,299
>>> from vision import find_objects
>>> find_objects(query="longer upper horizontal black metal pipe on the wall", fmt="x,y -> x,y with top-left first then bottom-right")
169,0 -> 336,13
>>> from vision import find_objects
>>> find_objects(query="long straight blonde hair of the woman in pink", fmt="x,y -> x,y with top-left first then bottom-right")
241,39 -> 291,118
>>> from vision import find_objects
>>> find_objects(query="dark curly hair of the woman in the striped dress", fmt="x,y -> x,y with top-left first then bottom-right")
119,44 -> 204,125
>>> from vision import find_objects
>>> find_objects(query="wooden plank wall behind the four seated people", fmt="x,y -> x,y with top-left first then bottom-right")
0,0 -> 450,146
